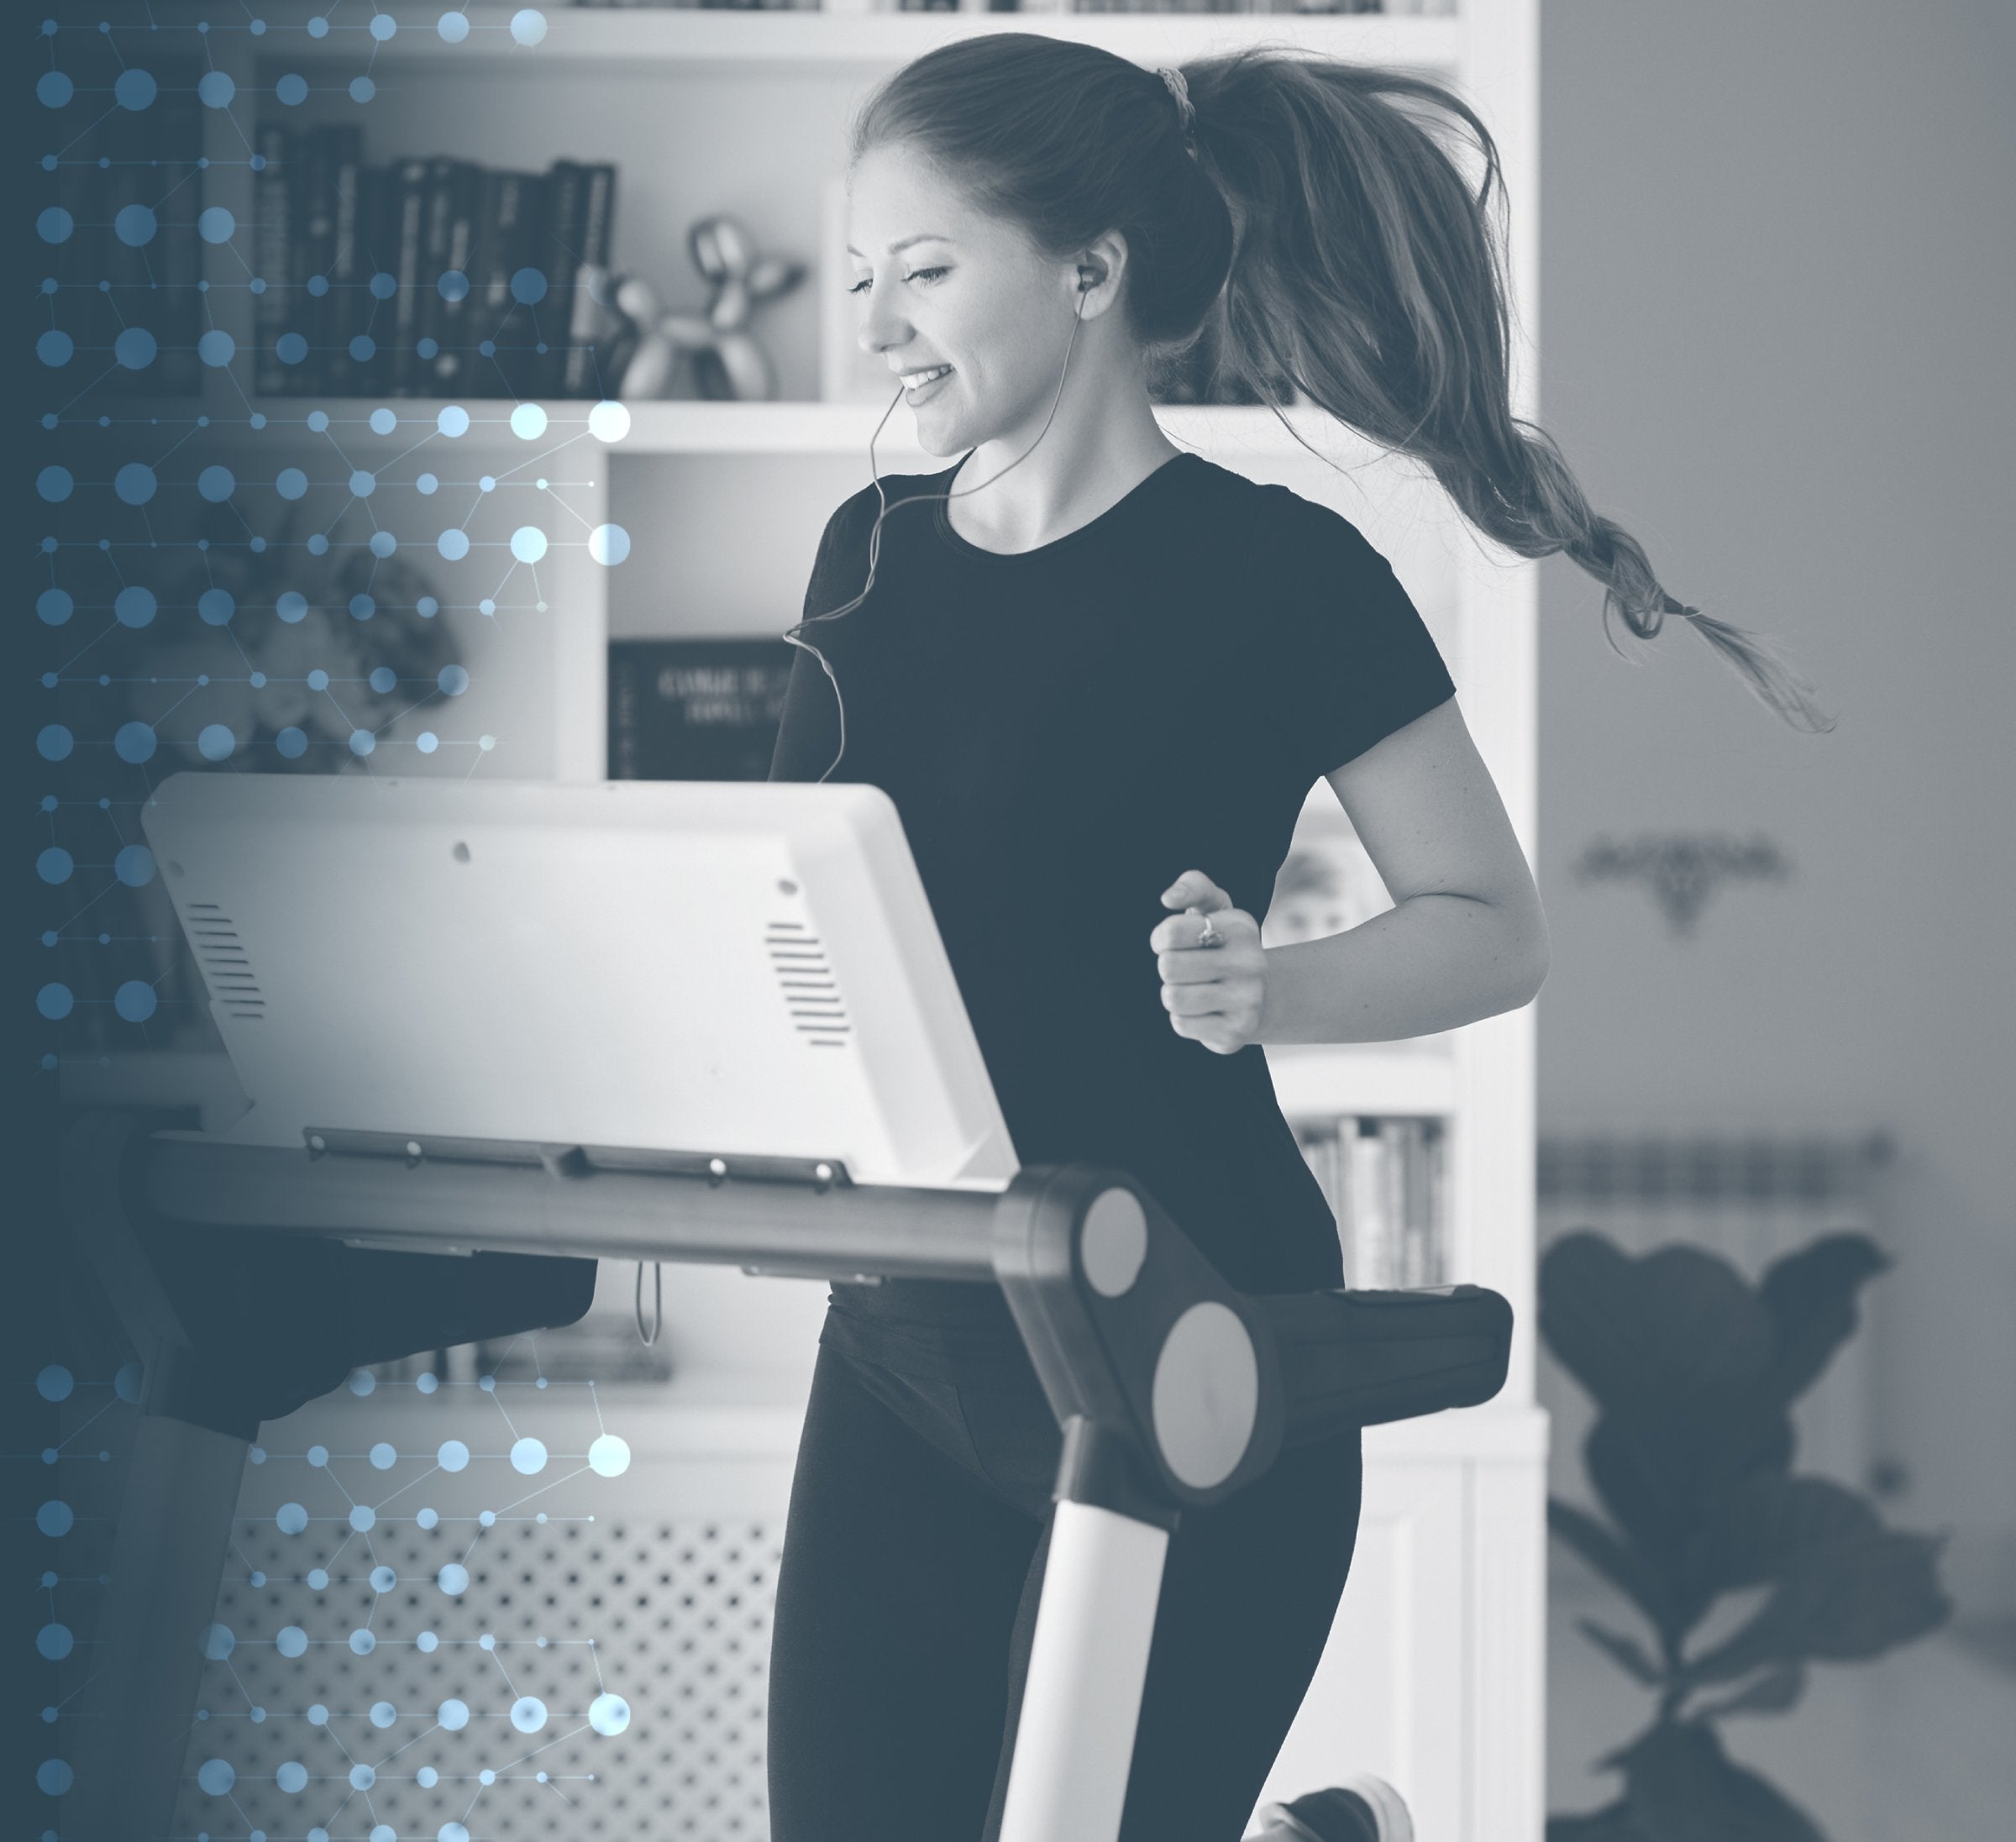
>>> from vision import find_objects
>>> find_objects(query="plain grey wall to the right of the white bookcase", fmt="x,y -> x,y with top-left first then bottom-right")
1536,0 -> 2016,1608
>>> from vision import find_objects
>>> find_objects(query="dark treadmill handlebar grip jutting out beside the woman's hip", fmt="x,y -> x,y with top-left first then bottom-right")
1252,1286 -> 1512,1445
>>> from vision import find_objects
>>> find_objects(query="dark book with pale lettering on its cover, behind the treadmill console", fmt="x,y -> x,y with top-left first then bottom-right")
609,639 -> 792,780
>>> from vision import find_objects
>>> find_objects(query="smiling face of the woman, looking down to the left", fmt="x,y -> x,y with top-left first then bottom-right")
847,147 -> 1117,454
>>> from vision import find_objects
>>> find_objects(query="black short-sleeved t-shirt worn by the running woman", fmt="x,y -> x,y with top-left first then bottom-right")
770,454 -> 1456,1378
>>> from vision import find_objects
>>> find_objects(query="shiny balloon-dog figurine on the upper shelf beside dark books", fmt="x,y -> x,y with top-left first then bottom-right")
613,213 -> 806,403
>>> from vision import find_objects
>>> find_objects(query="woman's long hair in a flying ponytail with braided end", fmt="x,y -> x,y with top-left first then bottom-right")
848,32 -> 1835,732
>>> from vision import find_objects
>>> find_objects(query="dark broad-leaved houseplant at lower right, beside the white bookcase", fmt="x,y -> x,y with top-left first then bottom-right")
1541,1230 -> 1951,1842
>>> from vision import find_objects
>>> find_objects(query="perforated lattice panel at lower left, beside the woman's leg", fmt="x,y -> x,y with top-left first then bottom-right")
173,1467 -> 782,1842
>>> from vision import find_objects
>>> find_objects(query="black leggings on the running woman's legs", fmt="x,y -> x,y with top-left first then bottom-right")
768,1344 -> 1362,1842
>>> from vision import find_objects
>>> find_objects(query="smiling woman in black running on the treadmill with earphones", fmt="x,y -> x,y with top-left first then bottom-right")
768,32 -> 1824,1842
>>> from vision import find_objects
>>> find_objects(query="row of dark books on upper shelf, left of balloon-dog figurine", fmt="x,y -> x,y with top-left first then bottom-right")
254,121 -> 627,397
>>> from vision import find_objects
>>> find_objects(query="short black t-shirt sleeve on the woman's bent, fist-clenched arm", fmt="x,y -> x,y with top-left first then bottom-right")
1262,494 -> 1456,786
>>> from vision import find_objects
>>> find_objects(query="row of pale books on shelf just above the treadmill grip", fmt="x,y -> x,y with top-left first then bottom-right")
1296,1115 -> 1450,1292
